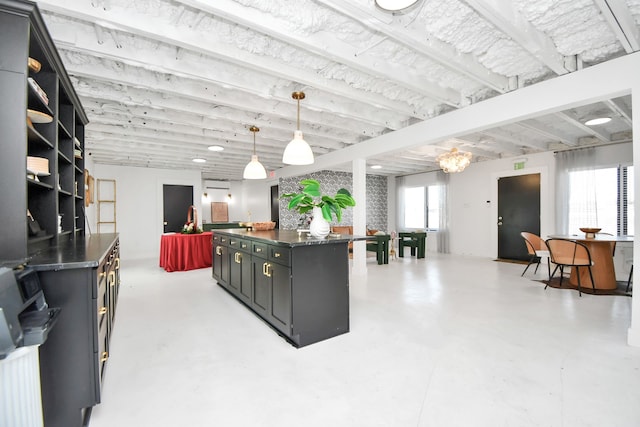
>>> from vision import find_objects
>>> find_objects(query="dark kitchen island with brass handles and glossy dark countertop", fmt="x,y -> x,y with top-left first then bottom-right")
212,229 -> 352,347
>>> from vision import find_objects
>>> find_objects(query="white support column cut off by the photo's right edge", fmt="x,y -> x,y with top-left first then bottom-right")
627,83 -> 640,347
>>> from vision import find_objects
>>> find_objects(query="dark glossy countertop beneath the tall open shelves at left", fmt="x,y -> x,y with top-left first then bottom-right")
29,233 -> 118,271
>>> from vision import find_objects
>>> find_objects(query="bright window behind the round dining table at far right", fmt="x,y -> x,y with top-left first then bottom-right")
568,166 -> 635,235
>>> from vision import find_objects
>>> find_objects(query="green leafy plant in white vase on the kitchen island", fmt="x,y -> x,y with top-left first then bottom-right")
280,179 -> 356,238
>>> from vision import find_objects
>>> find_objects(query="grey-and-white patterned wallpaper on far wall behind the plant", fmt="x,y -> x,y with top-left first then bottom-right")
278,171 -> 387,231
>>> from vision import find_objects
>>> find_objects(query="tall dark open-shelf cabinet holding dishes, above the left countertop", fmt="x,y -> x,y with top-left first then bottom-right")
0,0 -> 88,262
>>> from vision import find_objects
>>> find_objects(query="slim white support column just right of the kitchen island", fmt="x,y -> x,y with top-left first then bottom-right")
351,159 -> 367,276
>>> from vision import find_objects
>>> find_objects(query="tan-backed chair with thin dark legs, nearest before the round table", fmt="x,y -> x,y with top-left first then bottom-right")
544,239 -> 596,296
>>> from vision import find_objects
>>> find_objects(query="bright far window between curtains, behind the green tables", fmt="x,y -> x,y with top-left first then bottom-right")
404,185 -> 442,229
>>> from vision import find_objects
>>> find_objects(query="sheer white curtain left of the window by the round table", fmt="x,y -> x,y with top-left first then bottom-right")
555,148 -> 598,234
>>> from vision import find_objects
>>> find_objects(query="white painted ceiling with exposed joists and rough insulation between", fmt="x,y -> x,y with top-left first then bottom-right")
38,0 -> 640,180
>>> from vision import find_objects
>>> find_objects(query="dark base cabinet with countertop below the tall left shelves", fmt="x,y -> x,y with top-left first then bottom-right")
30,234 -> 120,427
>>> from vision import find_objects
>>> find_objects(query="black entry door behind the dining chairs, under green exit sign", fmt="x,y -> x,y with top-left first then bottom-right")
498,173 -> 540,261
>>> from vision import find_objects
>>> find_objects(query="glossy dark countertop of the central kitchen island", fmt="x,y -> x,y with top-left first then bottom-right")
211,229 -> 367,247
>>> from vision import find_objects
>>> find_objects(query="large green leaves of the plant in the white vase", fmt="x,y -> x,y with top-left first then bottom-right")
280,179 -> 356,222
